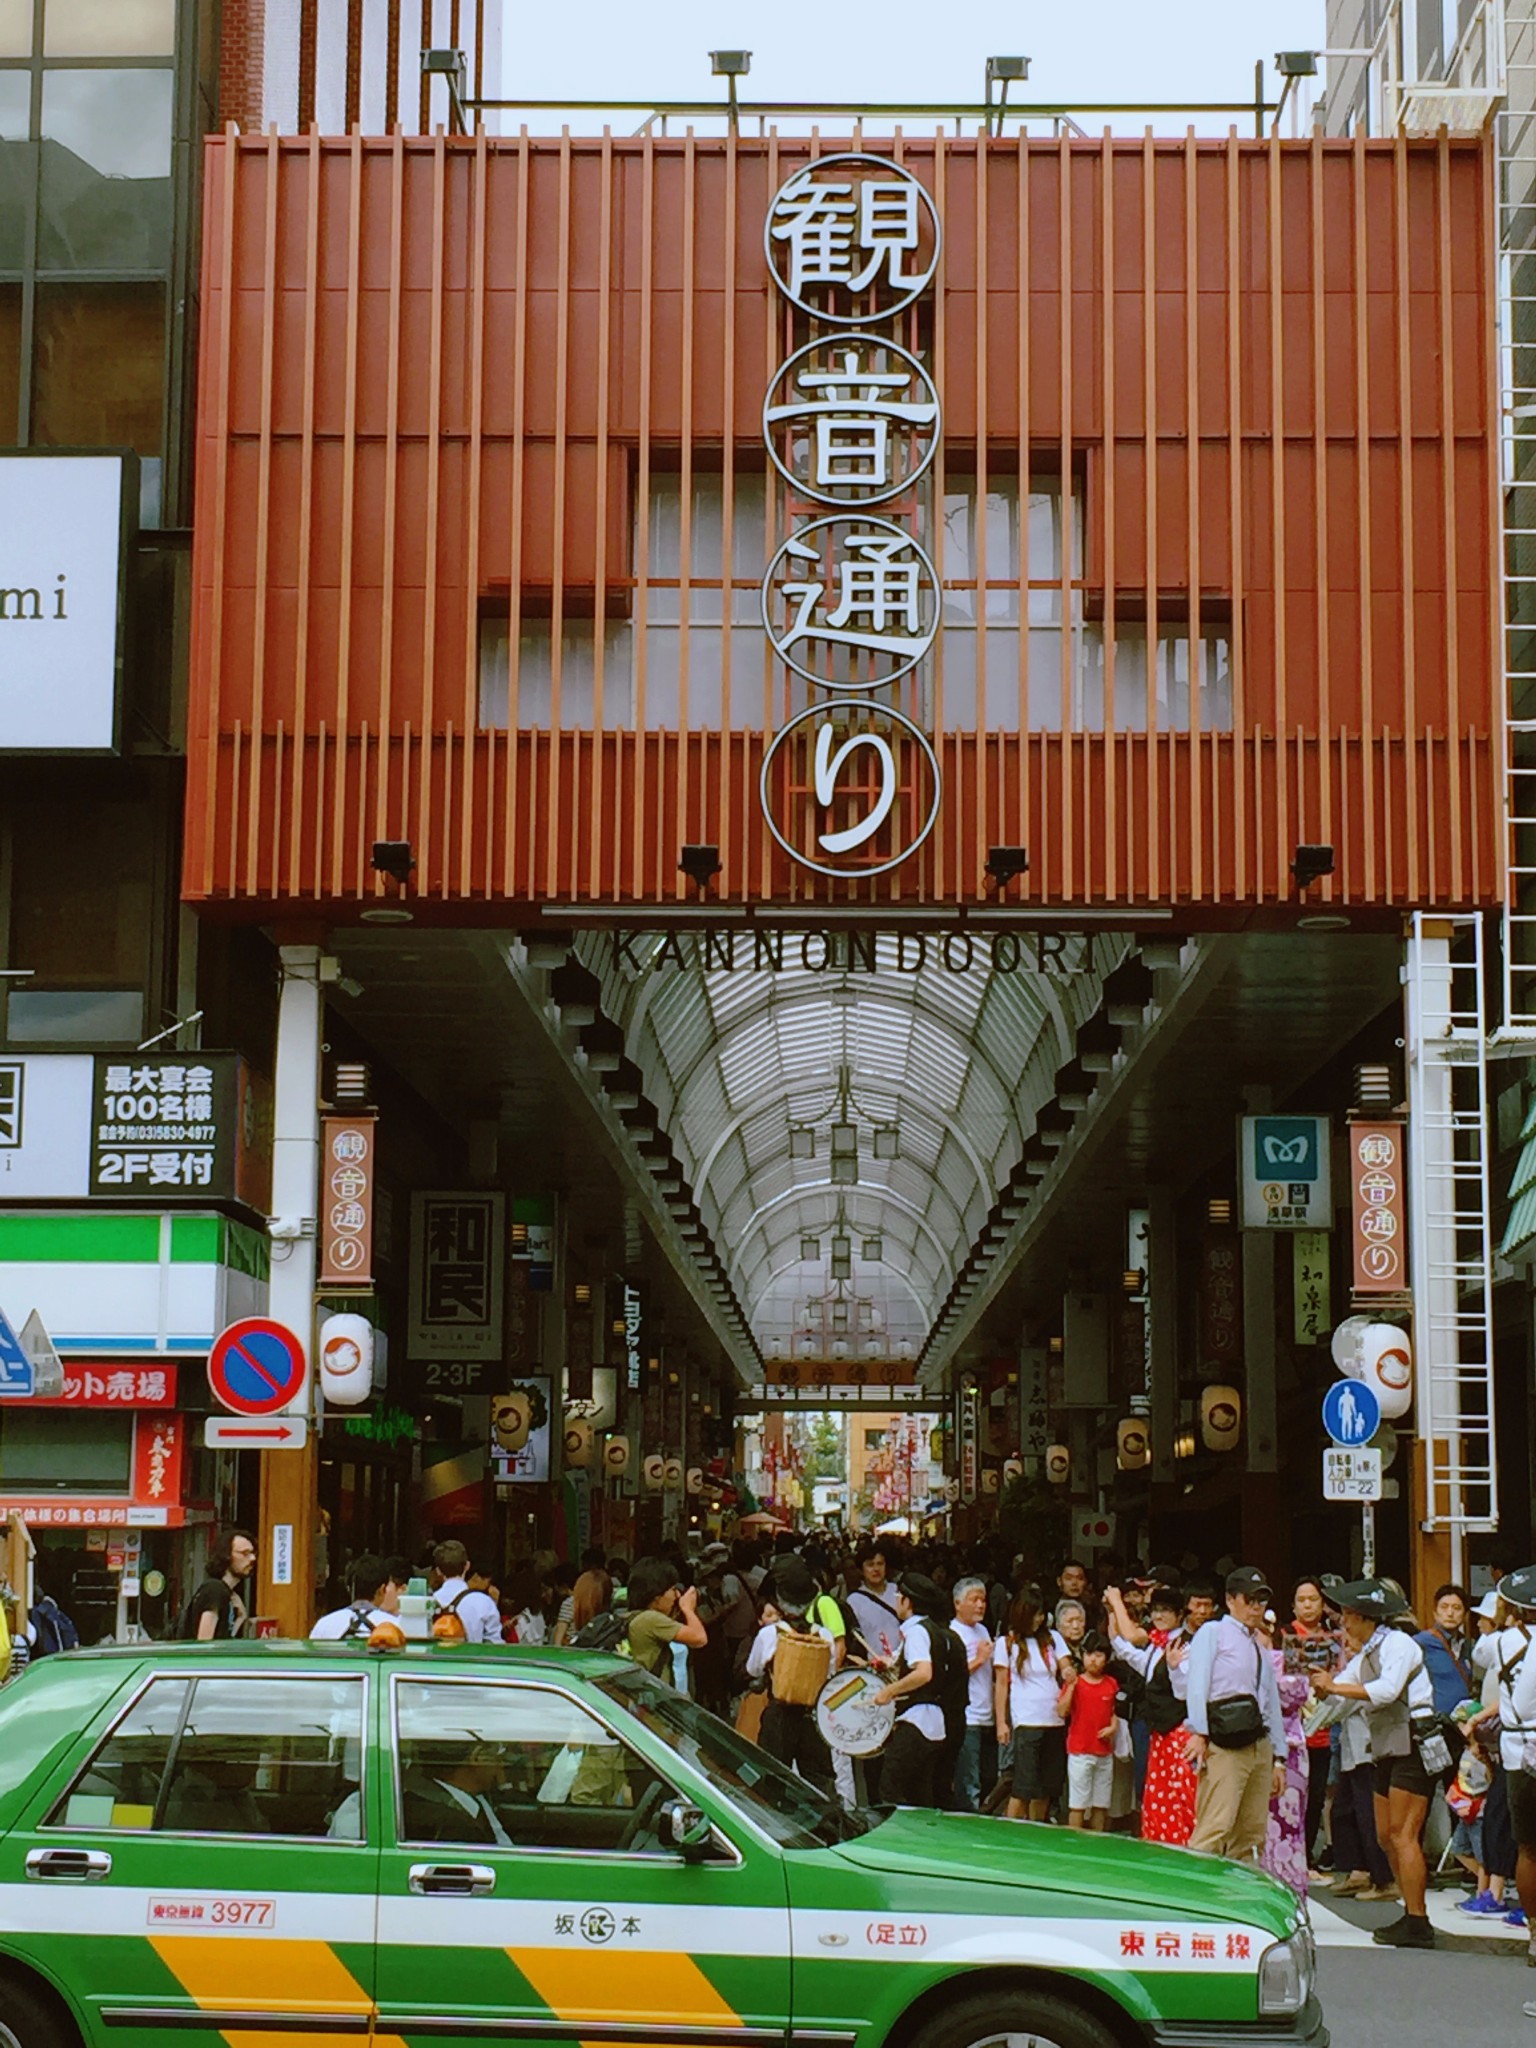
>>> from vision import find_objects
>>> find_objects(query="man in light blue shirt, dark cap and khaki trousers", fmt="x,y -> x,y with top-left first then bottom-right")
1184,1565 -> 1286,1862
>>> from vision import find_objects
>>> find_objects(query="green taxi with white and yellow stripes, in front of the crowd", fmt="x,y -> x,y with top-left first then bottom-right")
0,1642 -> 1327,2048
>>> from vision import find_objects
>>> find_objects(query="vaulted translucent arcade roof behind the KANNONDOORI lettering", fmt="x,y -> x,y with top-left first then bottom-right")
578,932 -> 1126,1358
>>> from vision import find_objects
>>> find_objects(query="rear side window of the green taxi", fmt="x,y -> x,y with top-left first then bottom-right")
51,1677 -> 365,1841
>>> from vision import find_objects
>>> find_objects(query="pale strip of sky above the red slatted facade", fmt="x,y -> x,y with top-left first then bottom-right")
502,0 -> 1325,131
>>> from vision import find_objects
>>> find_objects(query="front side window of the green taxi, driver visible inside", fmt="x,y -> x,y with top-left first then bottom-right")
395,1679 -> 674,1855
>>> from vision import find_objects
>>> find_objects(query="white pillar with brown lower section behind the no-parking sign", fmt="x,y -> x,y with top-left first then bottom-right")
256,946 -> 324,1636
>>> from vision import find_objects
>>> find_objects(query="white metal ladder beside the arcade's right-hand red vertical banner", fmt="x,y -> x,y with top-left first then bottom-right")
1403,911 -> 1499,1538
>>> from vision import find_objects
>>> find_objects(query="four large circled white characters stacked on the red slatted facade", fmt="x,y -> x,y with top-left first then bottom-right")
760,154 -> 940,879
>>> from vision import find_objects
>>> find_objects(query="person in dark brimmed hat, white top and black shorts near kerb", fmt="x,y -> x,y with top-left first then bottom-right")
1313,1579 -> 1438,1948
